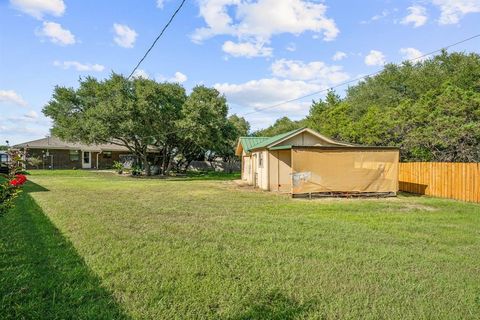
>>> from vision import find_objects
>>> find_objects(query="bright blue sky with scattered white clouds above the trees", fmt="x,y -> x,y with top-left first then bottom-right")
0,0 -> 480,144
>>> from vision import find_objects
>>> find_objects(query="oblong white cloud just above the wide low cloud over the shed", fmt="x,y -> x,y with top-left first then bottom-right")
271,59 -> 349,85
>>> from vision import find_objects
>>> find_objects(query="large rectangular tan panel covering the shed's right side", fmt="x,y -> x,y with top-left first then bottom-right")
292,149 -> 399,193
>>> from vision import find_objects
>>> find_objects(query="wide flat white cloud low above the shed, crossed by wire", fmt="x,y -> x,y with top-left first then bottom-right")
214,78 -> 318,113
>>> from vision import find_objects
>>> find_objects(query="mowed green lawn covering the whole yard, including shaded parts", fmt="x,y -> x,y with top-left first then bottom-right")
0,171 -> 480,319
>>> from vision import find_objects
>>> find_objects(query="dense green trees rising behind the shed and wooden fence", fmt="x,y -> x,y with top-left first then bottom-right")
303,52 -> 480,162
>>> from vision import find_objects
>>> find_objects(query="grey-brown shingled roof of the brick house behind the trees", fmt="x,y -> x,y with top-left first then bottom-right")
13,136 -> 129,152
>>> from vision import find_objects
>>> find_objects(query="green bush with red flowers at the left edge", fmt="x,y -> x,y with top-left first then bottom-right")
0,150 -> 27,216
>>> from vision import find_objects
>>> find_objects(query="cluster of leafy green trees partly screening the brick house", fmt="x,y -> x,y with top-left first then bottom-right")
43,74 -> 248,175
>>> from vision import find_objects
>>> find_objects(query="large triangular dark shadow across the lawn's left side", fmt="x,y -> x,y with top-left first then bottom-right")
0,182 -> 128,319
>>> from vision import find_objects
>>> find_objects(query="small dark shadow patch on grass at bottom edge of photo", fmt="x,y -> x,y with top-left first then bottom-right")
229,291 -> 313,320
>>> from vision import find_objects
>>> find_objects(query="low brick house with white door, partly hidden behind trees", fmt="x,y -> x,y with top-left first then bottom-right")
13,136 -> 137,169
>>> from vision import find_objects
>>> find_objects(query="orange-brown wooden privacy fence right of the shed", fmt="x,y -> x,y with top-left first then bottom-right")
398,162 -> 480,202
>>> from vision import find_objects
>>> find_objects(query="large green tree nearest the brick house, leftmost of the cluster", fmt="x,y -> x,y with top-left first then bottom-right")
43,74 -> 186,175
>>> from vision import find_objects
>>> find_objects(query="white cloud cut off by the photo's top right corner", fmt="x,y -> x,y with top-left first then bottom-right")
432,0 -> 480,24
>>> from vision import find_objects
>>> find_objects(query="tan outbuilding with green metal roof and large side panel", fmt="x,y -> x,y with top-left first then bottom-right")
236,128 -> 399,195
